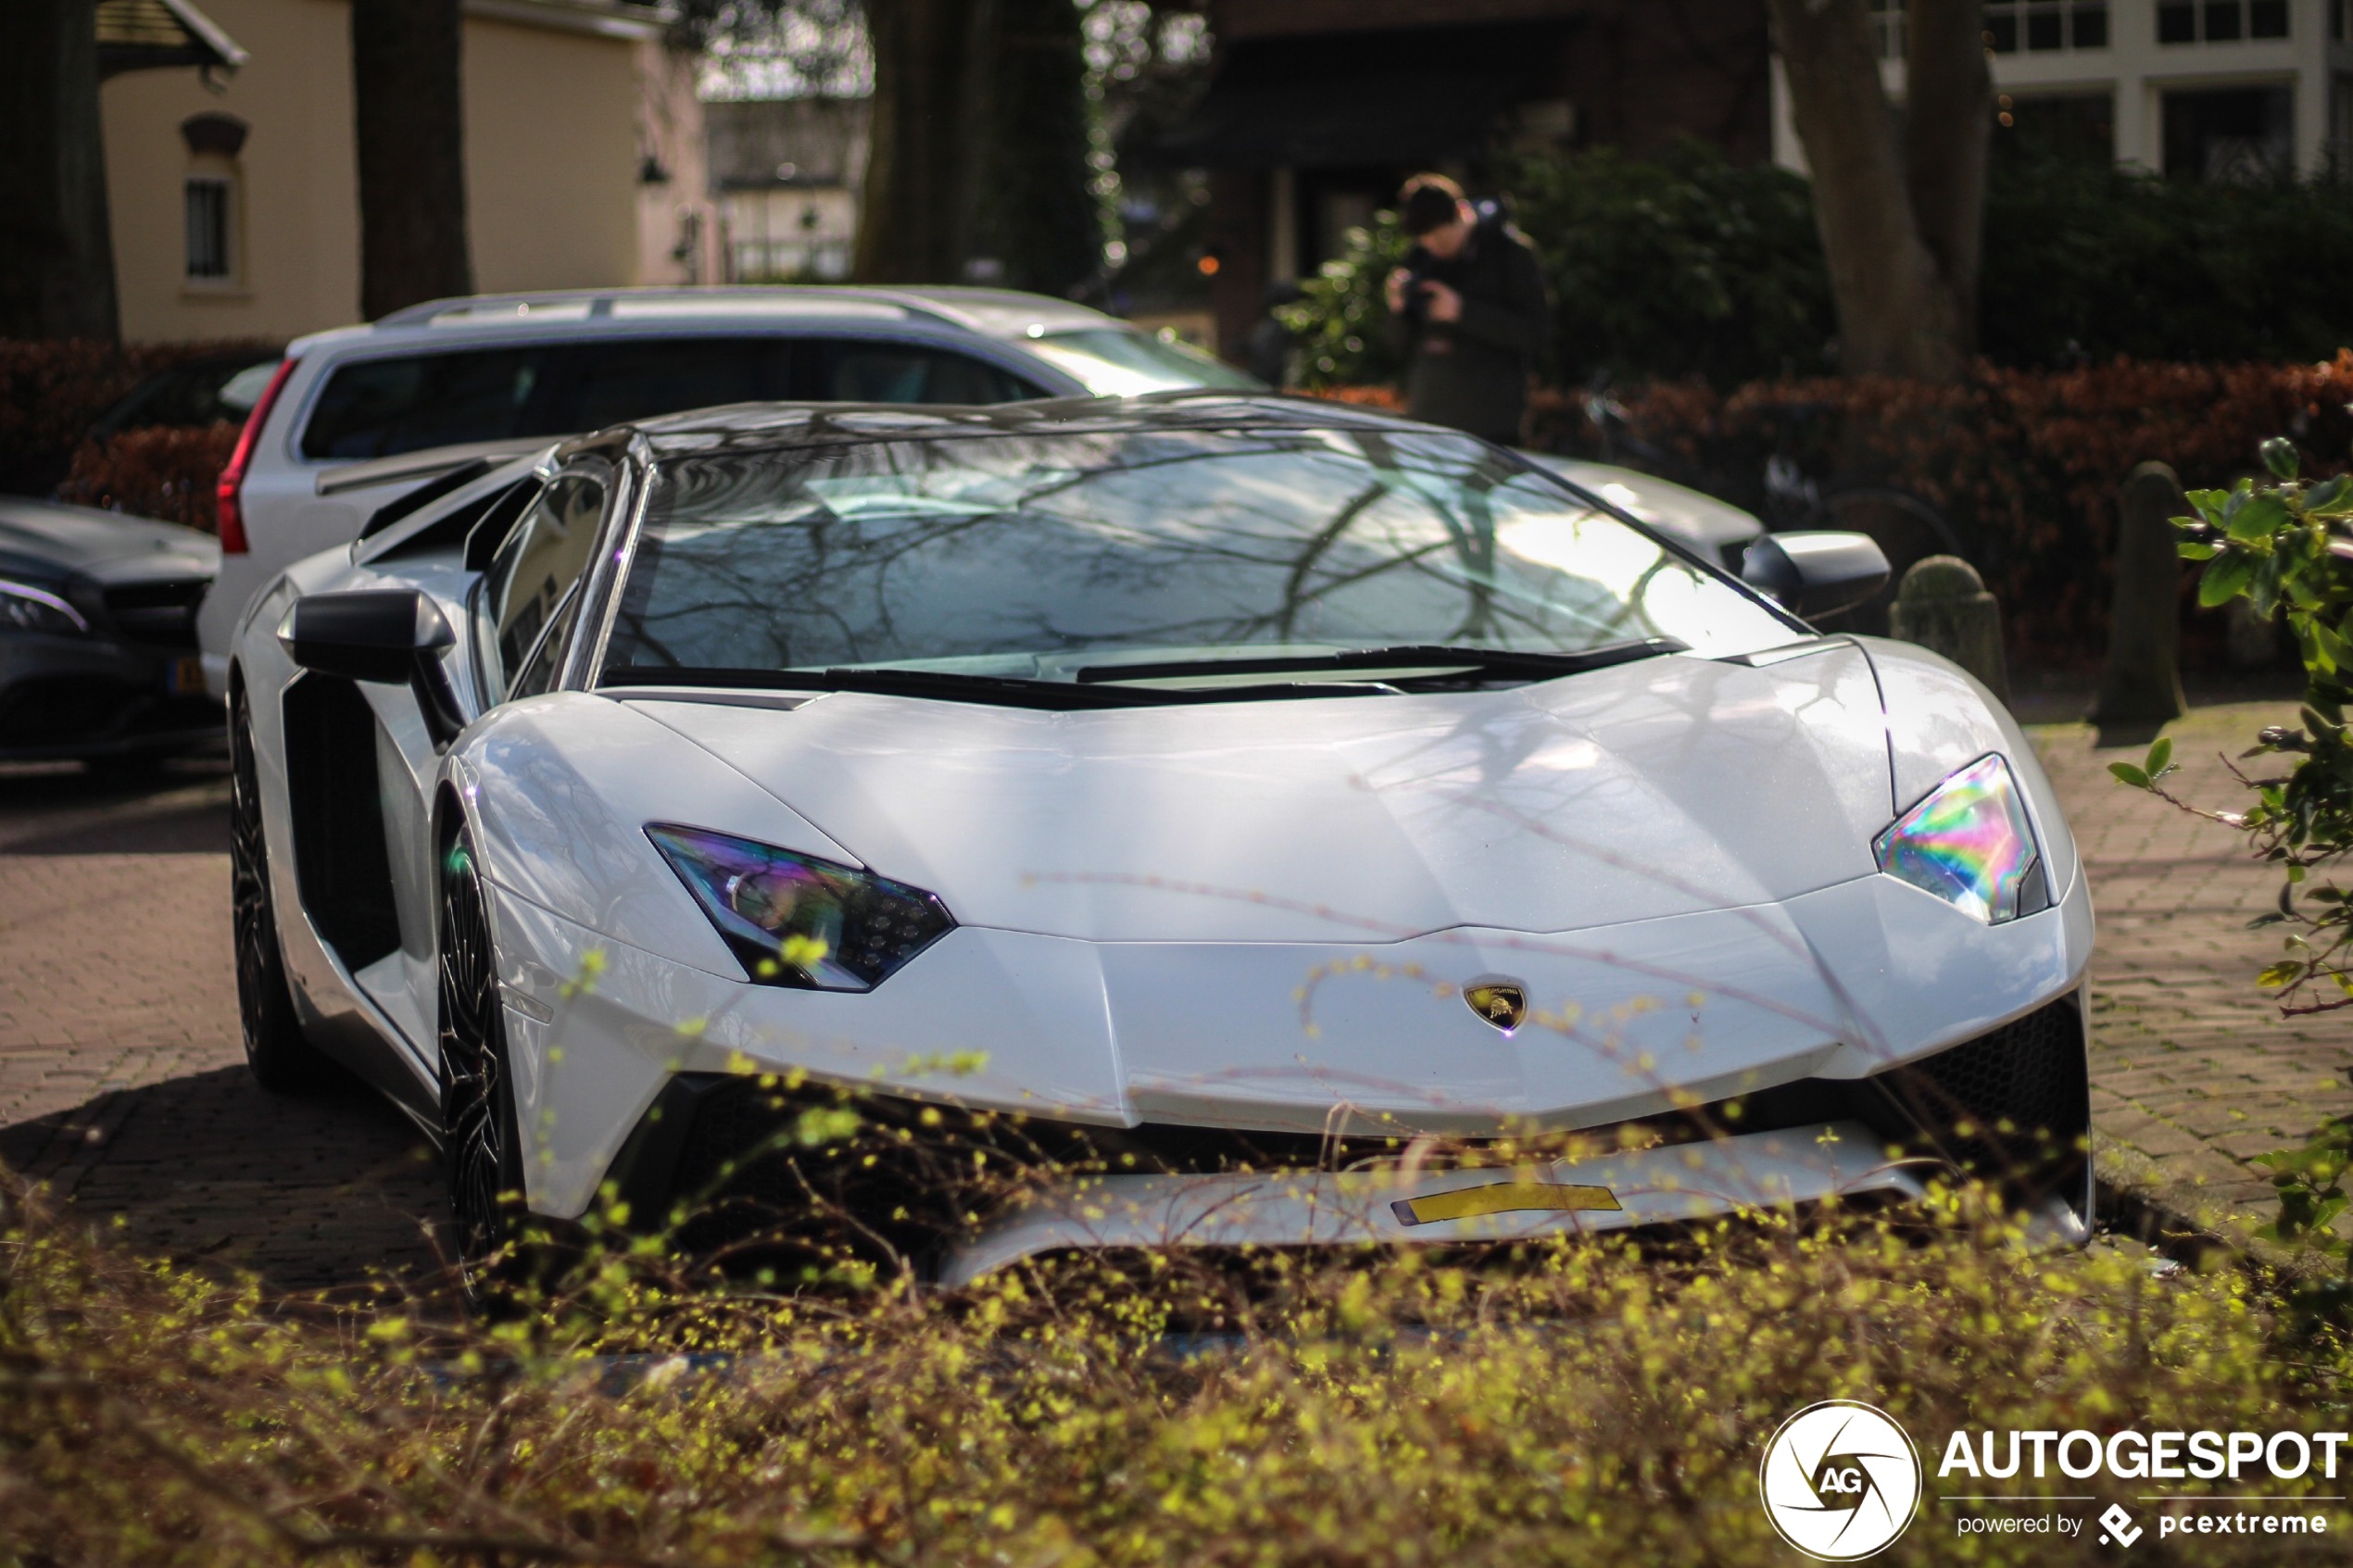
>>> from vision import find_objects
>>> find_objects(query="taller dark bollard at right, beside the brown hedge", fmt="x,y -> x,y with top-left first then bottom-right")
2092,463 -> 2188,743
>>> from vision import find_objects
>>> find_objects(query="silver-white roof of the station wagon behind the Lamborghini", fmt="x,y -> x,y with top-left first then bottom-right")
287,284 -> 1123,355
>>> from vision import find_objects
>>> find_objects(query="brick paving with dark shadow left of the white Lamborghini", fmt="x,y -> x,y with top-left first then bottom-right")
0,764 -> 440,1290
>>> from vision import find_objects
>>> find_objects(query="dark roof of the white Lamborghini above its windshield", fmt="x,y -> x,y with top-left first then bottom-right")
598,388 -> 1452,458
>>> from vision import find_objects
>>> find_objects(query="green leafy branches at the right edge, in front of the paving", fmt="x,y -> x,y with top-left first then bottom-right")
2108,437 -> 2353,1279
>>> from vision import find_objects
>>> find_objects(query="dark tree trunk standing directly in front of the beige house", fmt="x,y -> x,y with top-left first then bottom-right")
350,0 -> 473,320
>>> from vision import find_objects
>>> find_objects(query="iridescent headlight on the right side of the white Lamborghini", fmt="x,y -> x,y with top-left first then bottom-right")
1870,757 -> 2052,926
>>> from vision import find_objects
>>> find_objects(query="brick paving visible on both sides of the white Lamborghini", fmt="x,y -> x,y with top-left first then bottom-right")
0,703 -> 2353,1288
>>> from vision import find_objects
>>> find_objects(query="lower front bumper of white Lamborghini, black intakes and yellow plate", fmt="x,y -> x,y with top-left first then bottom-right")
598,997 -> 2092,1286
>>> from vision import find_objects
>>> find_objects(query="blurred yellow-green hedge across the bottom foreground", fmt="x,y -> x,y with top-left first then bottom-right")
0,1198 -> 2348,1568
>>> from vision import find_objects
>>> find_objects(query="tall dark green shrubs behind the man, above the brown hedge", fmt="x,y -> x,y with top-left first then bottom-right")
1285,141 -> 2353,388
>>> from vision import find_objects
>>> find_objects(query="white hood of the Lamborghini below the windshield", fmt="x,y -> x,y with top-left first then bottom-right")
607,642 -> 1890,943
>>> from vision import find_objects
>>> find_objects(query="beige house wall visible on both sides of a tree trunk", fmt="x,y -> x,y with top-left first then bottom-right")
98,0 -> 649,341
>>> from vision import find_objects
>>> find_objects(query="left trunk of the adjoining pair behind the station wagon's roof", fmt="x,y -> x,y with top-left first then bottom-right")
851,0 -> 995,282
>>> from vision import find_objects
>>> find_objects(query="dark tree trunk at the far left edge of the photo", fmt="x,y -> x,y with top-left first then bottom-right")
0,0 -> 120,341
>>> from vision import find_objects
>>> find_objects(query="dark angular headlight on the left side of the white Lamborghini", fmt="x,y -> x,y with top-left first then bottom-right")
645,822 -> 955,992
